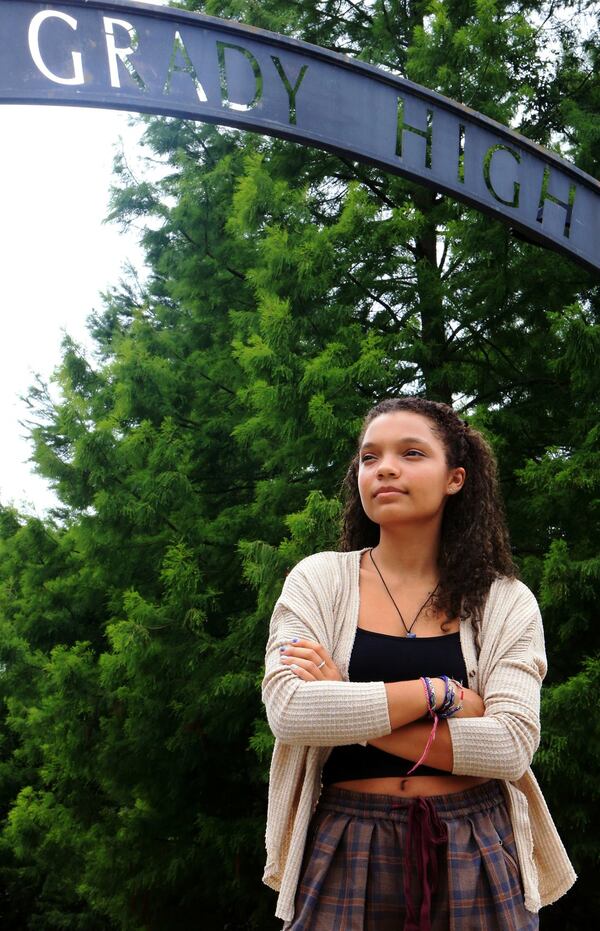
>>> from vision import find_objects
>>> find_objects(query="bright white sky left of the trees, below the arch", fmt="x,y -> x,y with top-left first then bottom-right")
0,0 -> 165,515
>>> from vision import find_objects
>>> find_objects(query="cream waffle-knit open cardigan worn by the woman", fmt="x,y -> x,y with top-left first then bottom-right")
263,550 -> 576,921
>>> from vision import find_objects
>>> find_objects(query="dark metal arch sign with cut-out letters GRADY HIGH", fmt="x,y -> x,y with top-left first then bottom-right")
0,0 -> 600,271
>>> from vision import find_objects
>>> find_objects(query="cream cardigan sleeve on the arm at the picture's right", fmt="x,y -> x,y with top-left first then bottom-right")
448,582 -> 547,782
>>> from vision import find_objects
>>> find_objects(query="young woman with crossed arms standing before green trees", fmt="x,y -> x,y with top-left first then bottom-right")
263,398 -> 575,931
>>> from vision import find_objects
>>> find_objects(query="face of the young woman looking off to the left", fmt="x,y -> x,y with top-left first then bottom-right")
358,411 -> 465,527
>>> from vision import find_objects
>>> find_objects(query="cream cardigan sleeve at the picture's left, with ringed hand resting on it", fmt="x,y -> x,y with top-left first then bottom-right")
262,557 -> 391,747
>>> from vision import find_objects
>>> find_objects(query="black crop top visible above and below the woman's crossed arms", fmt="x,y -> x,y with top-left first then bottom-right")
322,627 -> 467,785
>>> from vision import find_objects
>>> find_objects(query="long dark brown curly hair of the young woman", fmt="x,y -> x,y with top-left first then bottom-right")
340,397 -> 516,628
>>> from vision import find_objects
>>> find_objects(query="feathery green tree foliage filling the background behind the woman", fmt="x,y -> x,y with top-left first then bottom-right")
0,0 -> 600,931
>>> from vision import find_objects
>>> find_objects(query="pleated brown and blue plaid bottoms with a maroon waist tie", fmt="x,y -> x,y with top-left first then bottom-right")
284,781 -> 539,931
